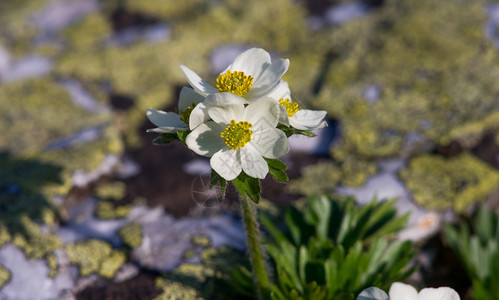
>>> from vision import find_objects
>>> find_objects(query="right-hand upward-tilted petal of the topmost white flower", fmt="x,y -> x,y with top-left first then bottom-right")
245,59 -> 289,99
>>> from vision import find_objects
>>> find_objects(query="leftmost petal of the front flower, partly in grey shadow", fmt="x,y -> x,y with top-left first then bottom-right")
185,121 -> 228,157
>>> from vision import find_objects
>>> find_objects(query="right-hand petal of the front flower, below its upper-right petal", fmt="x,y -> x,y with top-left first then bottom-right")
250,127 -> 289,158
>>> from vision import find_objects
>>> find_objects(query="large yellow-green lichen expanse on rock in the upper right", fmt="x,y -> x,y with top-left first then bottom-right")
314,0 -> 499,159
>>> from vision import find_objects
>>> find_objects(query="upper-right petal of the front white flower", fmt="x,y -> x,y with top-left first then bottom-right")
243,98 -> 279,130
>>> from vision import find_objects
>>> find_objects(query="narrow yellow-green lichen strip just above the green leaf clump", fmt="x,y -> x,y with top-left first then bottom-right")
288,159 -> 377,196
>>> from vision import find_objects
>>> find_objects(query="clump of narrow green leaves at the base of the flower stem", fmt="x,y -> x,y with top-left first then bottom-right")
229,196 -> 414,299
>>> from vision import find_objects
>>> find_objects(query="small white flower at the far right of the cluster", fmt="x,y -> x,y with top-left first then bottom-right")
268,81 -> 327,130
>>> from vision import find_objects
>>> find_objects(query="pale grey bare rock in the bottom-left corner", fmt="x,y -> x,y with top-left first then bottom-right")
0,244 -> 74,300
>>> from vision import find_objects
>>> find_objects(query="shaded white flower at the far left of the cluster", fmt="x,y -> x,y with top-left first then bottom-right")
147,87 -> 207,133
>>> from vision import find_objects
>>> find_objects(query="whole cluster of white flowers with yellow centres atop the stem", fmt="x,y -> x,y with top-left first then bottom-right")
147,48 -> 326,199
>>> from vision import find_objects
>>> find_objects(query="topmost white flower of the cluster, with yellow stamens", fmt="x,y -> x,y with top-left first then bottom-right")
180,48 -> 289,100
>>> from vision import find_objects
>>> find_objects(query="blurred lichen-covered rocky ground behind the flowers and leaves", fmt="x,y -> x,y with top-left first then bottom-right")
0,0 -> 499,299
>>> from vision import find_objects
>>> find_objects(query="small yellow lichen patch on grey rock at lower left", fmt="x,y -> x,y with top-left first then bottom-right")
65,239 -> 126,278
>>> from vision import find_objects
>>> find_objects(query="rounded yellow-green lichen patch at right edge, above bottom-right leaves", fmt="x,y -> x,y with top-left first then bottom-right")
400,153 -> 499,212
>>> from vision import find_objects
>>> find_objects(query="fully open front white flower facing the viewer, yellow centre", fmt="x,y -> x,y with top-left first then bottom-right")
186,93 -> 289,180
